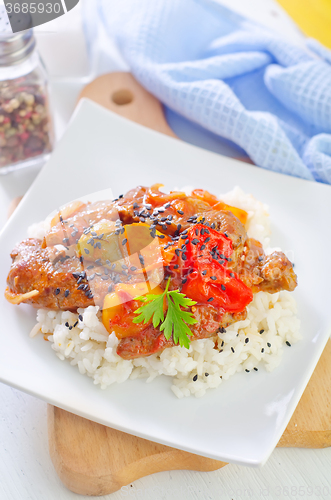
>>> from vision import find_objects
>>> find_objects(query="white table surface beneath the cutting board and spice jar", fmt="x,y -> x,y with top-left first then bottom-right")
0,0 -> 331,500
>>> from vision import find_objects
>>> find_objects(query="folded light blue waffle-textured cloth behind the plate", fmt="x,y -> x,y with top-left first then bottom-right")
85,0 -> 331,184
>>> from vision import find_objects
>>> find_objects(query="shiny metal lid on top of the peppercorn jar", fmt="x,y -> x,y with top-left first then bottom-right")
0,5 -> 36,67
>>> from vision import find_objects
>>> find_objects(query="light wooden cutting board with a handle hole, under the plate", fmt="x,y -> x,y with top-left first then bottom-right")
41,73 -> 331,495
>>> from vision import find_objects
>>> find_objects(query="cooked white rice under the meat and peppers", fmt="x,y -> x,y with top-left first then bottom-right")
29,187 -> 301,398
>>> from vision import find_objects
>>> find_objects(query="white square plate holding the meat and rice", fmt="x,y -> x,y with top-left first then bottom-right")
0,100 -> 331,465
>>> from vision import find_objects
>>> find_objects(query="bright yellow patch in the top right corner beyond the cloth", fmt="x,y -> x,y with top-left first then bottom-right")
277,0 -> 331,48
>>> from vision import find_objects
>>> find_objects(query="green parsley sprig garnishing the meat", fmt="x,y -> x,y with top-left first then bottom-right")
133,278 -> 198,349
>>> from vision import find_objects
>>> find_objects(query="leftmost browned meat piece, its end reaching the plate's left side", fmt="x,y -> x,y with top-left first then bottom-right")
6,238 -> 141,311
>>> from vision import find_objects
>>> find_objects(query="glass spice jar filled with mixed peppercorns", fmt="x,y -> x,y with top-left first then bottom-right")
0,6 -> 53,175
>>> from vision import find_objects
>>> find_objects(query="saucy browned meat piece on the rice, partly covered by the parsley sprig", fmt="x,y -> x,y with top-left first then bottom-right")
117,305 -> 247,359
